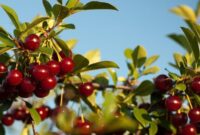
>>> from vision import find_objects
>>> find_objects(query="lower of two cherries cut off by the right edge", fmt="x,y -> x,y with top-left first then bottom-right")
188,108 -> 200,123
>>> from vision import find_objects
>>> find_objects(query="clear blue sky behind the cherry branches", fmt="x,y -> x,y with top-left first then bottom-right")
0,0 -> 198,79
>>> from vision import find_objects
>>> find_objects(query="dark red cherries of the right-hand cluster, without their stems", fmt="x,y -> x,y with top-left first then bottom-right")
154,75 -> 200,135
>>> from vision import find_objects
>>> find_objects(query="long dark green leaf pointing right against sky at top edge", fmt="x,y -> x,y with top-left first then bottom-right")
82,1 -> 118,10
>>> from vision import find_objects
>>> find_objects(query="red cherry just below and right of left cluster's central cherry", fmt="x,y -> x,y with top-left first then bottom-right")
41,76 -> 57,90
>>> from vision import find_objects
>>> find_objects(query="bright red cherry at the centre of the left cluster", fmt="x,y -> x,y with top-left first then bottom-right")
32,65 -> 50,81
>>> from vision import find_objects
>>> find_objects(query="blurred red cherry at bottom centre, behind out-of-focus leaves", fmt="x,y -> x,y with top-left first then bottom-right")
74,117 -> 91,135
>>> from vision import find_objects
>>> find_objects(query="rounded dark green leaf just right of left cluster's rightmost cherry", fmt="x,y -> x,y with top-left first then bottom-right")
73,54 -> 89,72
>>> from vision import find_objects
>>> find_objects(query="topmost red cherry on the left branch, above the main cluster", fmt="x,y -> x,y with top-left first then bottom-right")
24,34 -> 40,51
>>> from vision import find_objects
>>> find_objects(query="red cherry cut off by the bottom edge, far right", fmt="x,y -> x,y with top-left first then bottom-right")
182,124 -> 197,135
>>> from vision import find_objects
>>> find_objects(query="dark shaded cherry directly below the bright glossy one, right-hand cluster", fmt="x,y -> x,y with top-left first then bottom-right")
172,112 -> 188,127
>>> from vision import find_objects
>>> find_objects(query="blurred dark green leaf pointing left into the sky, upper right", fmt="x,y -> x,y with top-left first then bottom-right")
168,34 -> 192,53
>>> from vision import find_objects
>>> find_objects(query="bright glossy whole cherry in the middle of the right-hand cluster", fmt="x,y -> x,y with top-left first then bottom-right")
165,96 -> 182,111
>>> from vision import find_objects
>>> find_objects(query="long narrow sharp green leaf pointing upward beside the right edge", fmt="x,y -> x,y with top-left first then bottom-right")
182,27 -> 199,62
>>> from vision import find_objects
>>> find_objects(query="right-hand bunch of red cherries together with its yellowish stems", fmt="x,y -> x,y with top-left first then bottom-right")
154,75 -> 200,135
